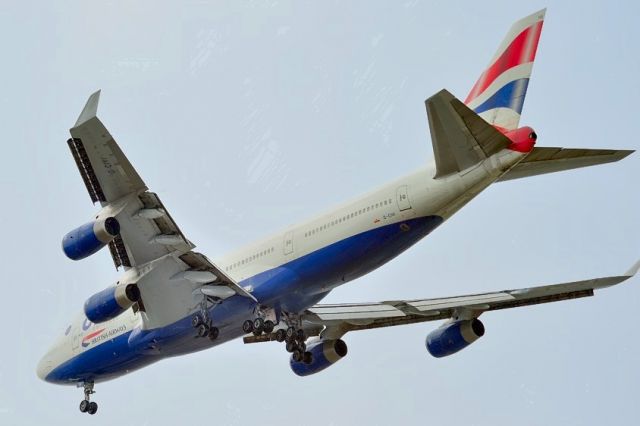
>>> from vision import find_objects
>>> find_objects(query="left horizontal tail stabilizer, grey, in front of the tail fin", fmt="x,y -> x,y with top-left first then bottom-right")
425,89 -> 511,178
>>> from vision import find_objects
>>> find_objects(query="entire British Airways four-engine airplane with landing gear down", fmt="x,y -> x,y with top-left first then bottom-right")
37,9 -> 640,414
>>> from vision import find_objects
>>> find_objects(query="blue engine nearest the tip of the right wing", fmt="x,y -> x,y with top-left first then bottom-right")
426,318 -> 484,358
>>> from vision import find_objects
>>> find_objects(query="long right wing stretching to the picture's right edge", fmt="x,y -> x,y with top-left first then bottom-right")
244,261 -> 640,343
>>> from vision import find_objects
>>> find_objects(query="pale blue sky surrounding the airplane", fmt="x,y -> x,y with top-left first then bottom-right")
0,0 -> 640,426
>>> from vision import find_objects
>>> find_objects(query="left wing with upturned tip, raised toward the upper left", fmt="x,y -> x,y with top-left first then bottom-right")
68,91 -> 255,328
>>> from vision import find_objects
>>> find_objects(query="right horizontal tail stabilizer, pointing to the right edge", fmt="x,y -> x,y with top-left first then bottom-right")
498,147 -> 634,182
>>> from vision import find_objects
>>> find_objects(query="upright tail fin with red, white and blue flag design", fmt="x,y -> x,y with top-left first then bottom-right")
465,9 -> 546,132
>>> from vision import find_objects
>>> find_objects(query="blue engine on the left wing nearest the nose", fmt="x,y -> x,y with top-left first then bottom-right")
84,284 -> 140,324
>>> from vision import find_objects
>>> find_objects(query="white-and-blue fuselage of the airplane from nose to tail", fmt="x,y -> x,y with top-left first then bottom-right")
38,150 -> 525,383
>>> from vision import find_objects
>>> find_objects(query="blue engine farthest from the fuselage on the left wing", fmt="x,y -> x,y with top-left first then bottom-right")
62,217 -> 120,260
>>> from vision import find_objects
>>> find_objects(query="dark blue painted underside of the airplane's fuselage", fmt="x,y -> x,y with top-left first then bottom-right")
47,216 -> 442,383
